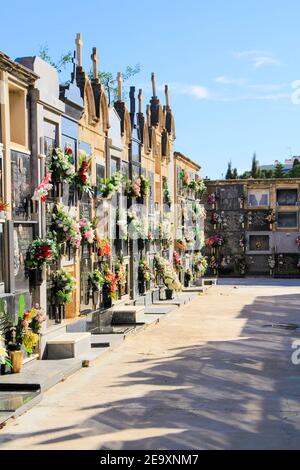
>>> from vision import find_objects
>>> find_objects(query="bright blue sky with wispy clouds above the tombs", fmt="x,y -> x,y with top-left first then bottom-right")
0,0 -> 300,178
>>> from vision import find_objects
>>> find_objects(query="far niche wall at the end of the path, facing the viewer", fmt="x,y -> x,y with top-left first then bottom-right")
204,178 -> 300,278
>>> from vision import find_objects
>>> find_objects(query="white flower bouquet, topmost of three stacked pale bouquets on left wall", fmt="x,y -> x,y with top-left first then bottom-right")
47,147 -> 75,183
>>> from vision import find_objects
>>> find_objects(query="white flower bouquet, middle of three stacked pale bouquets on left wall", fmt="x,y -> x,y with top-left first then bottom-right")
51,204 -> 81,248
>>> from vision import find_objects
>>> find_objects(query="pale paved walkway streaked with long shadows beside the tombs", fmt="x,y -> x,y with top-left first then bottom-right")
0,283 -> 300,450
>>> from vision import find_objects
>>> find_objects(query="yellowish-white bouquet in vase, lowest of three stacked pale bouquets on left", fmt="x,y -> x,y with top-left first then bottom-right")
52,269 -> 76,323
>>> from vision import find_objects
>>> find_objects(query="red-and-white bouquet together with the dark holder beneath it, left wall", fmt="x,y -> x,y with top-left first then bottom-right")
25,238 -> 58,286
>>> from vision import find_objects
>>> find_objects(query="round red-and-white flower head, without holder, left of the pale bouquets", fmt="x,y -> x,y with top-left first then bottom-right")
25,238 -> 58,270
